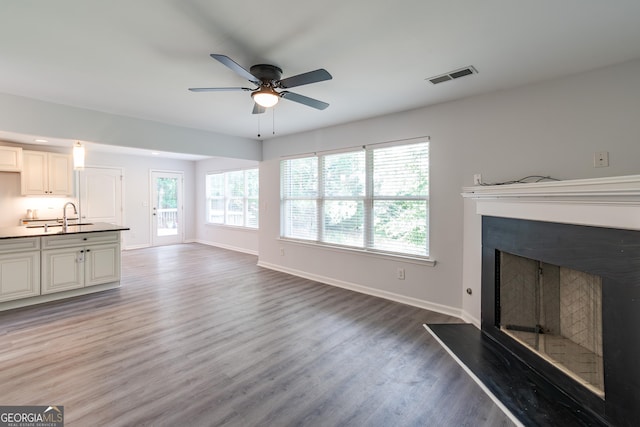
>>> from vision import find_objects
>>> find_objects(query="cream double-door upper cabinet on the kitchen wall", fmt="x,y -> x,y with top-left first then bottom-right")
20,150 -> 73,196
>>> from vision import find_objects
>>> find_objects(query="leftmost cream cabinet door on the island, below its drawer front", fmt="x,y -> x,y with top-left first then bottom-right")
0,251 -> 40,301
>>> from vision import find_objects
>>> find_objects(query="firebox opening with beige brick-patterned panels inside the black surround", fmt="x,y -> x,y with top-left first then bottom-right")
496,251 -> 605,399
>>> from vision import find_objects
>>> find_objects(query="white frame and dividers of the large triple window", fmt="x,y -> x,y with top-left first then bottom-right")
280,137 -> 435,264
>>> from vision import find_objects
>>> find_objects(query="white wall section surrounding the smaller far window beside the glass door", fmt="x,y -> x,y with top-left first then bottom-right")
194,158 -> 258,255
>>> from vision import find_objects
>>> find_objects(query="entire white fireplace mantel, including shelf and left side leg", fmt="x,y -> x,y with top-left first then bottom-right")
462,175 -> 640,327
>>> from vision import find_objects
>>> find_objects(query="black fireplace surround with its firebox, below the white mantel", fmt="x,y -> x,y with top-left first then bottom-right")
481,215 -> 640,425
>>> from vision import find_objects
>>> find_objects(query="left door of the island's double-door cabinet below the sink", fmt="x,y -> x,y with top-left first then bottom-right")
42,248 -> 84,295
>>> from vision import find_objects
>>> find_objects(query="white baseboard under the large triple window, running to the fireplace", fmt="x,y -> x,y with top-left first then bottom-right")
258,261 -> 462,318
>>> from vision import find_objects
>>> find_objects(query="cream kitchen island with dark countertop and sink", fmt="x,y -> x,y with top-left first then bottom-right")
0,223 -> 129,311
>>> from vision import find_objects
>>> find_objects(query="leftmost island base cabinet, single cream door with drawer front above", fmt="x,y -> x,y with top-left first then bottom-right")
0,237 -> 40,302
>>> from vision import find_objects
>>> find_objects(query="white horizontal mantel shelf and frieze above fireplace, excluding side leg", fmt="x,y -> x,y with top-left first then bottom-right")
462,175 -> 640,230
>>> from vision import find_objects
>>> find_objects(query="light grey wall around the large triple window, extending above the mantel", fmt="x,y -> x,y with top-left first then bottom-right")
259,60 -> 640,318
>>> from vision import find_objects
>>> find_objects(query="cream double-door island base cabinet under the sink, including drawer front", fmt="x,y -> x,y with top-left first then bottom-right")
42,232 -> 120,295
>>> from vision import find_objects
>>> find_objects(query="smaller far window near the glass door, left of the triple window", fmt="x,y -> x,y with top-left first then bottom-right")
206,169 -> 259,228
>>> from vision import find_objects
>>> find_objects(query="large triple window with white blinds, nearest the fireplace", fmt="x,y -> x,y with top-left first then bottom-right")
280,141 -> 429,256
